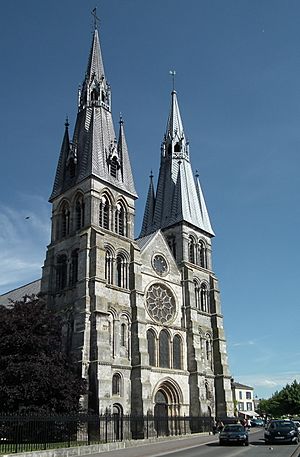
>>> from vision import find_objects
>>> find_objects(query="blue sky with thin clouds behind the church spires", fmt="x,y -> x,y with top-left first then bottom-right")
0,0 -> 300,397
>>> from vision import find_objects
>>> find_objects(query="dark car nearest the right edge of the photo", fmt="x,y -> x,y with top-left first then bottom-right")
265,419 -> 299,444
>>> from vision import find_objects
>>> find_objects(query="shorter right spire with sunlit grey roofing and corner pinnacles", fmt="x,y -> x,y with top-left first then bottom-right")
140,90 -> 214,237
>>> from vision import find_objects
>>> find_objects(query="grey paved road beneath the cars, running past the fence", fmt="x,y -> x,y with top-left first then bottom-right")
82,429 -> 300,457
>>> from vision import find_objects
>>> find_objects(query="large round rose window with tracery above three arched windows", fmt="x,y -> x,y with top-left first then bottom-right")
146,284 -> 176,324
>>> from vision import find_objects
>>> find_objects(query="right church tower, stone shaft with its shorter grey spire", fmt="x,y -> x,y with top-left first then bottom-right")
140,90 -> 233,417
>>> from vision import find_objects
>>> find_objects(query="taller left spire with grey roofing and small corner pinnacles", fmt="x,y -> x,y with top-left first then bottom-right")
50,28 -> 137,201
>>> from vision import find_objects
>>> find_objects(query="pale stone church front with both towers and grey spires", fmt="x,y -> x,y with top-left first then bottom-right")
41,22 -> 234,424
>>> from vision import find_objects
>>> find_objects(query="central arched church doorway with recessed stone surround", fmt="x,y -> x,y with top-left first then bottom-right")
154,380 -> 182,436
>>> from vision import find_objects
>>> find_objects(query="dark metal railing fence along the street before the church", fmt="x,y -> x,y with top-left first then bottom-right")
0,414 -> 213,454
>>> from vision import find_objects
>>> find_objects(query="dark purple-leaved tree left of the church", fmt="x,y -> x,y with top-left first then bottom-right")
0,299 -> 85,414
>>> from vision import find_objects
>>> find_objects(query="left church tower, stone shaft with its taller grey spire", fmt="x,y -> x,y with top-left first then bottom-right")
42,23 -> 137,413
